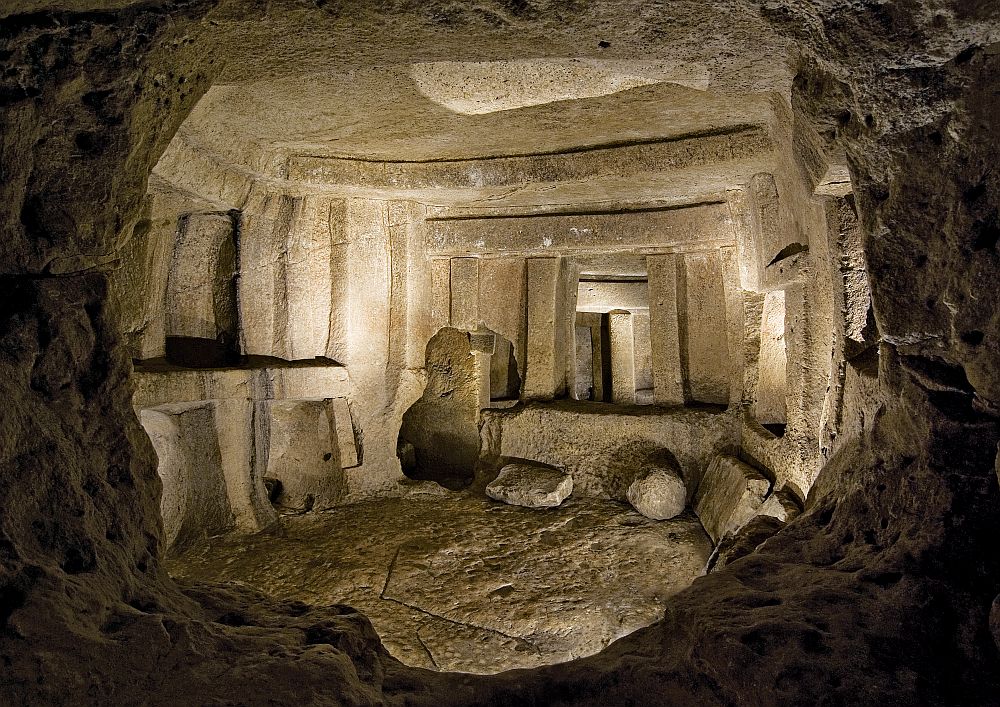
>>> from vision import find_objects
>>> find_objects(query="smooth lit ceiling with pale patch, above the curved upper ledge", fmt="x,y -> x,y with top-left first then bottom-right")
176,70 -> 771,167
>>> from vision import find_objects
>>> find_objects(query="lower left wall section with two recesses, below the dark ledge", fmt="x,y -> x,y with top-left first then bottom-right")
132,359 -> 358,542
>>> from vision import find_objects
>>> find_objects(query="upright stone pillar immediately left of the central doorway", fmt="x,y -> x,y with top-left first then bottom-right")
524,258 -> 564,400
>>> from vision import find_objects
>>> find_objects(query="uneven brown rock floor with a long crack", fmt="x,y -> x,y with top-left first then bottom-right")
168,494 -> 711,673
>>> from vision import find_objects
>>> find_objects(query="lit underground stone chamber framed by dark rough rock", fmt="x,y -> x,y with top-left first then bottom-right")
119,54 -> 870,673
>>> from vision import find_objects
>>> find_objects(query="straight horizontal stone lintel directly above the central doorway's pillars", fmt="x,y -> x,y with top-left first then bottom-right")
426,202 -> 733,256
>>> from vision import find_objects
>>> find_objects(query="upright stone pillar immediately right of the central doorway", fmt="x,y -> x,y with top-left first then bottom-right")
646,255 -> 684,405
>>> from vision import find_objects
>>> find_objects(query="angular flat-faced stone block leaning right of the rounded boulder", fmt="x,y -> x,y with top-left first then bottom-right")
694,455 -> 771,542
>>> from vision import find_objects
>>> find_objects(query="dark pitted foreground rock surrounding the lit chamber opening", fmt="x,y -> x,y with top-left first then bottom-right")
0,1 -> 1000,706
